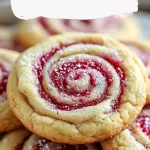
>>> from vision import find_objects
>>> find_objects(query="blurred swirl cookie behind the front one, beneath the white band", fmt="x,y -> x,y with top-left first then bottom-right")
16,16 -> 139,47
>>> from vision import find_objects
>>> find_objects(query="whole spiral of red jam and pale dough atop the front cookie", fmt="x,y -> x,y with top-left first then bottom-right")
33,43 -> 125,111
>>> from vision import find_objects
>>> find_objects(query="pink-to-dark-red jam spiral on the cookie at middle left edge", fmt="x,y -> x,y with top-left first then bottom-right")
0,59 -> 9,102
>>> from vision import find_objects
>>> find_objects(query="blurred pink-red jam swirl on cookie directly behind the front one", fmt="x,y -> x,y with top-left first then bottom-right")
37,16 -> 122,35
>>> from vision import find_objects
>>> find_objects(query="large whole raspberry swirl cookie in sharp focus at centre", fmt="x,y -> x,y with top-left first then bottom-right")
7,33 -> 147,144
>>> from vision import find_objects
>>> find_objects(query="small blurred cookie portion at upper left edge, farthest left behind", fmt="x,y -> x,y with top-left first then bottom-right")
0,26 -> 23,51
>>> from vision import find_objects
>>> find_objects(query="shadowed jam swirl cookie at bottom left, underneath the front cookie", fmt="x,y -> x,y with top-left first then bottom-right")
0,128 -> 102,150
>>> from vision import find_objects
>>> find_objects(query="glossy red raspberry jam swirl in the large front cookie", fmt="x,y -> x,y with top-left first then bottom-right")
33,43 -> 125,111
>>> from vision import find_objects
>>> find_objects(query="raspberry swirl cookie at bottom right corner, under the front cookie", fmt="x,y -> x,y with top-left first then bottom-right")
101,105 -> 150,150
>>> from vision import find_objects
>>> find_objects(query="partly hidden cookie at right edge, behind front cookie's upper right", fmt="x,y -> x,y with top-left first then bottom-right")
121,40 -> 150,103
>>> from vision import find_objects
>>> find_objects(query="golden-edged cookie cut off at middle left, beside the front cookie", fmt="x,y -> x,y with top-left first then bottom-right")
0,49 -> 21,132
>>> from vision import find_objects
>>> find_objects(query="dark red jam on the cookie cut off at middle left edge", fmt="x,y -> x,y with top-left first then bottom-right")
0,63 -> 9,100
